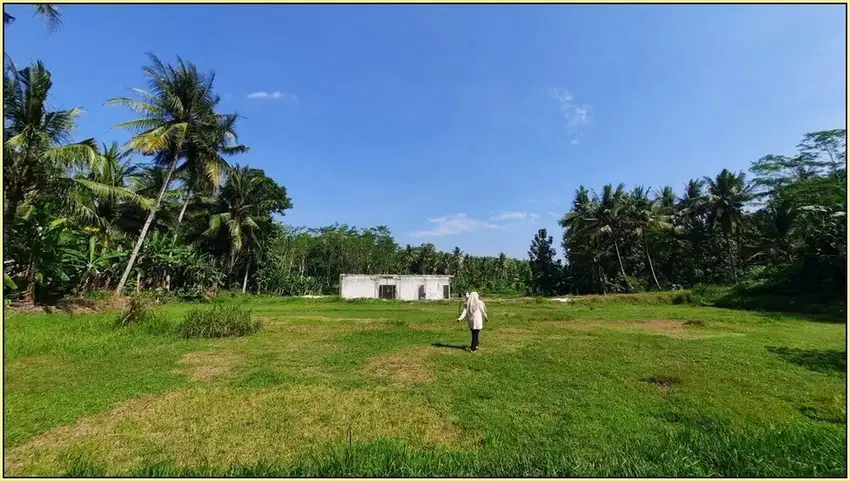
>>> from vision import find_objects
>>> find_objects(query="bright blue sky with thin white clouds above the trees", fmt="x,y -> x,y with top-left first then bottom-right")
5,5 -> 846,257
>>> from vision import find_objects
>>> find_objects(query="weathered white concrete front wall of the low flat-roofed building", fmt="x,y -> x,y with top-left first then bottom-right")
339,275 -> 451,301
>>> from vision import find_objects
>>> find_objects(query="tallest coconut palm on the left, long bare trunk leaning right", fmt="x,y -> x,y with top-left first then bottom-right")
108,54 -> 242,294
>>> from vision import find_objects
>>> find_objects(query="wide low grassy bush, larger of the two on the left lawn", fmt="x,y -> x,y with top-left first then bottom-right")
178,304 -> 262,339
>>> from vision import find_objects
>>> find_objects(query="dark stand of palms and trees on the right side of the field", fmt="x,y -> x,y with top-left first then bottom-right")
532,129 -> 847,296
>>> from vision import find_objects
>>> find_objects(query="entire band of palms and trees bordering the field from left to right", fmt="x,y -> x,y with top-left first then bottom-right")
3,4 -> 847,303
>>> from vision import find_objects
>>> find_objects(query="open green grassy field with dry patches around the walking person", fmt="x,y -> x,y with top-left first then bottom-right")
4,296 -> 847,477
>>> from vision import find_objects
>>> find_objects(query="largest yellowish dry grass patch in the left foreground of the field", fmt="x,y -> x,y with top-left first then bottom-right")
5,386 -> 475,476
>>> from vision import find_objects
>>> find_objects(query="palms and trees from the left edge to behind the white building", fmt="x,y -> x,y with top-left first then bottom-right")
3,47 -> 530,303
